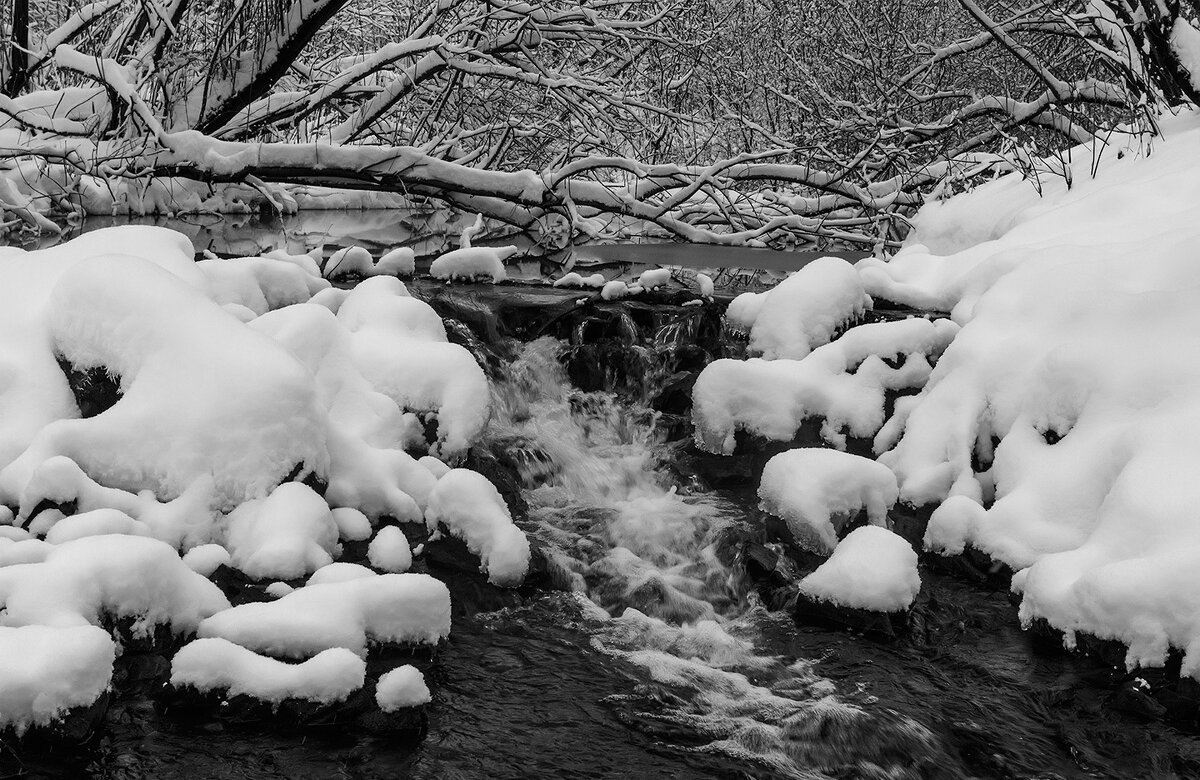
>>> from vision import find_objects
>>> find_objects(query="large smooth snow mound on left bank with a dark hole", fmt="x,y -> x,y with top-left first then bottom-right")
0,236 -> 326,506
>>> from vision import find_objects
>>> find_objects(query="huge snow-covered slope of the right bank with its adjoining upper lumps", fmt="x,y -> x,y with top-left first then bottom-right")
694,113 -> 1200,676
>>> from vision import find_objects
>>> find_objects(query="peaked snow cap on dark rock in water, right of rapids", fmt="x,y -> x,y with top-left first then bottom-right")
800,526 -> 920,612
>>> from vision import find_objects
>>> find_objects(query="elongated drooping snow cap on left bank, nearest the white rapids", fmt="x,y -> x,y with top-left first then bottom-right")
425,468 -> 529,587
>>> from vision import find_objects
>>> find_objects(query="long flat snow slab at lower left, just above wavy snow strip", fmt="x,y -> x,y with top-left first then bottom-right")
199,574 -> 450,658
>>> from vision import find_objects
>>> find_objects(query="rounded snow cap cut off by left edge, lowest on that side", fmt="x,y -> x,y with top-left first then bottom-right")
0,625 -> 116,736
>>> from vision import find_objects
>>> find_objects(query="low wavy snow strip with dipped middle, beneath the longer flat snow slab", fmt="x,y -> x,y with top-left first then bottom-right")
170,638 -> 367,704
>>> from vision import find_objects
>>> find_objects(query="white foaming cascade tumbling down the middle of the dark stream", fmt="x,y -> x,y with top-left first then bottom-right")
477,336 -> 932,778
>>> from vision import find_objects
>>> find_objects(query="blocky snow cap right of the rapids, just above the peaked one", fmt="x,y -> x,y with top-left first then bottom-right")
758,448 -> 899,552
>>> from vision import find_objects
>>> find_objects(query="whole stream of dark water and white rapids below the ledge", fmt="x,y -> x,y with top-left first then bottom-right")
0,220 -> 1200,779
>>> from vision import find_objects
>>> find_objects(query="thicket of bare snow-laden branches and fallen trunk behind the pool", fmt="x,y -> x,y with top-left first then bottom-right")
0,0 -> 1200,246
